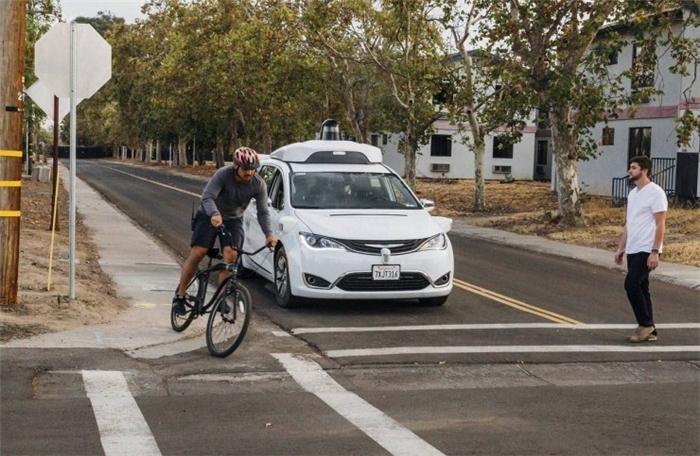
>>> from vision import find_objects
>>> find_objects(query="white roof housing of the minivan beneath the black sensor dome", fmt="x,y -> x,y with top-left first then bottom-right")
270,140 -> 382,164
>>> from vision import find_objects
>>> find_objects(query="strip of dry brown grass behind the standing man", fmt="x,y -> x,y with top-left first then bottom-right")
417,176 -> 700,266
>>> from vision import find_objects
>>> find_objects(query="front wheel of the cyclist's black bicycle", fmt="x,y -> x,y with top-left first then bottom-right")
207,283 -> 252,358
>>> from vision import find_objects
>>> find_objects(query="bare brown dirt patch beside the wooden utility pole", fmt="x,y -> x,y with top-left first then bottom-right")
0,179 -> 128,341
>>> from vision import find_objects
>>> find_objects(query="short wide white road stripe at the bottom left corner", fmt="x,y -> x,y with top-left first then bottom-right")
82,370 -> 161,456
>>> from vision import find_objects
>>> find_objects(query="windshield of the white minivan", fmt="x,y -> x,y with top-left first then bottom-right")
291,172 -> 422,209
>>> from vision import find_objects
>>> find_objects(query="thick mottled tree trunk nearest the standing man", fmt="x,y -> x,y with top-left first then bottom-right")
550,107 -> 583,226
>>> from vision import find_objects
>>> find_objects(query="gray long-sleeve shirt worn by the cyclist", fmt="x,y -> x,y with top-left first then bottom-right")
200,166 -> 272,236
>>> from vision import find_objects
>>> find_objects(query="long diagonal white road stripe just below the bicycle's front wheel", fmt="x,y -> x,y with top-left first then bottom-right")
272,353 -> 443,456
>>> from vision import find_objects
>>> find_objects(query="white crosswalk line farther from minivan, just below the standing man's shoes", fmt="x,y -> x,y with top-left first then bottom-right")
324,345 -> 700,358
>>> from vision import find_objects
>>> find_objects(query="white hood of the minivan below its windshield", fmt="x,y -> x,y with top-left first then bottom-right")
296,209 -> 449,241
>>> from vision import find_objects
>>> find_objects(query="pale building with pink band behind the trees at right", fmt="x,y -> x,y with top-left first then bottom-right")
380,4 -> 700,200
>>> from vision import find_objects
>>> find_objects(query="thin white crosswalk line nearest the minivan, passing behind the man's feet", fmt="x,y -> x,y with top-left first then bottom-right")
291,323 -> 700,335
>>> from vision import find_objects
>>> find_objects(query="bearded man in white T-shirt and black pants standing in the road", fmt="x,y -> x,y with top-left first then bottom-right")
615,156 -> 668,343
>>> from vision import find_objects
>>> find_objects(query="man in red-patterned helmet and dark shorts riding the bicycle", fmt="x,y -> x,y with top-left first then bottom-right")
173,147 -> 277,315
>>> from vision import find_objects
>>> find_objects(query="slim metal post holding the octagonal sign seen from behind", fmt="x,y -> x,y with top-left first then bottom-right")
68,21 -> 78,300
